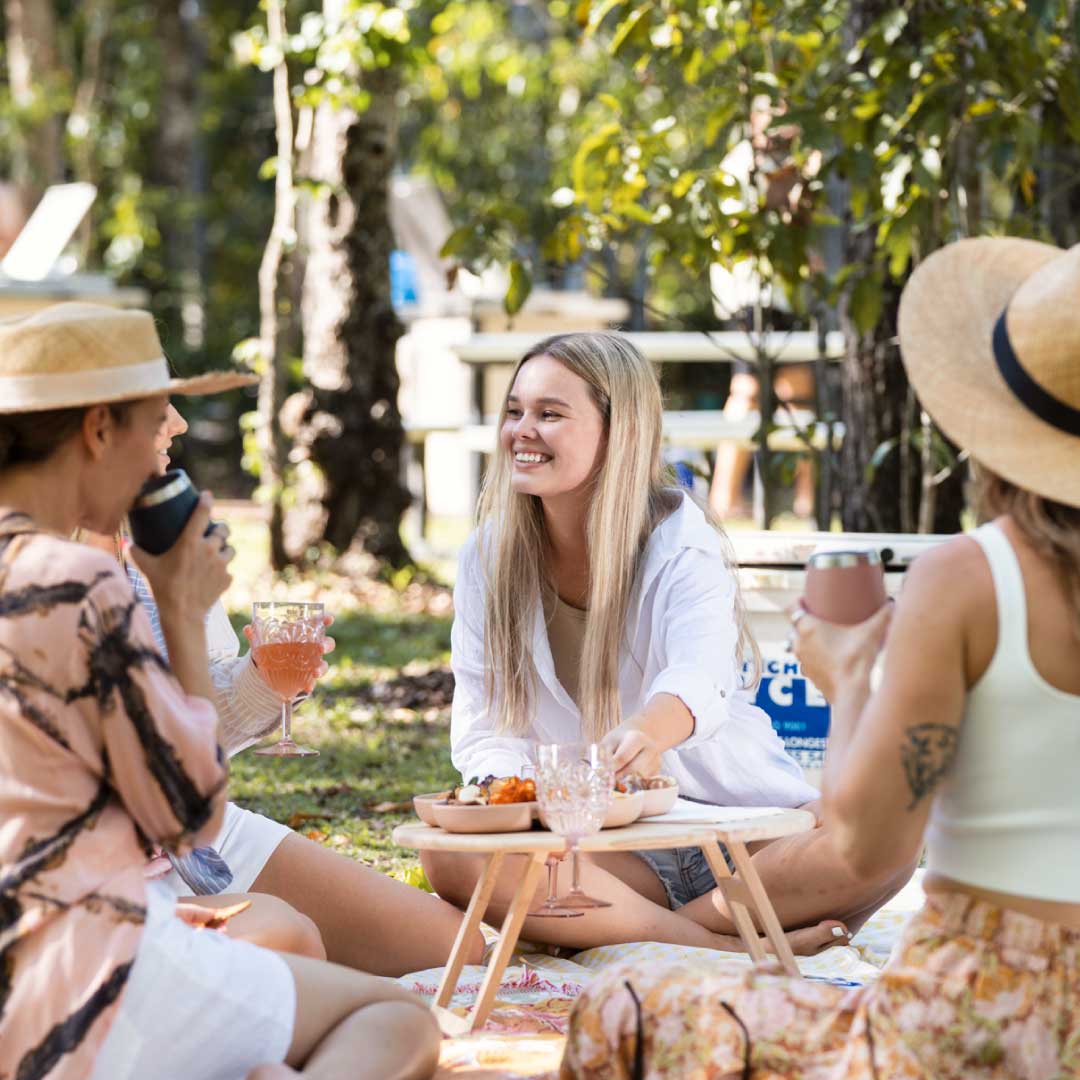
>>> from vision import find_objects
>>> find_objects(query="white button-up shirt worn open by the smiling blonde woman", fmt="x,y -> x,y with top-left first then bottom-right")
450,495 -> 818,807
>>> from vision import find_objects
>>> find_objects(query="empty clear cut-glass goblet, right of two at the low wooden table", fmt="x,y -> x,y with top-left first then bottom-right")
537,743 -> 615,910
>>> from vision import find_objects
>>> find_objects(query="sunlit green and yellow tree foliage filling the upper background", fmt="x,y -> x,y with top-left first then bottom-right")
0,0 -> 1080,532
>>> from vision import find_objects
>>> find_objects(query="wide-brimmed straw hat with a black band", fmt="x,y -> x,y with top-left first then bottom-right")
900,238 -> 1080,507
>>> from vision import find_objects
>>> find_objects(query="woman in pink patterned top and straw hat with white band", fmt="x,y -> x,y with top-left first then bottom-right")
0,303 -> 437,1080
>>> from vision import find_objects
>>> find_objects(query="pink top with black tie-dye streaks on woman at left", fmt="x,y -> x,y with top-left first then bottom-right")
0,510 -> 227,1080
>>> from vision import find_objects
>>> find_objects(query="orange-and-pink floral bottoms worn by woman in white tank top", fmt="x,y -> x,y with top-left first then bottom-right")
561,893 -> 1080,1080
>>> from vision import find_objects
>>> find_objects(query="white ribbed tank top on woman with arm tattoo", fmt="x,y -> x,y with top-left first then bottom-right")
927,524 -> 1080,902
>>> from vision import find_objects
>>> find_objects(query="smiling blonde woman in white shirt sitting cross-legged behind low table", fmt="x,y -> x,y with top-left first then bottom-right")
423,333 -> 906,953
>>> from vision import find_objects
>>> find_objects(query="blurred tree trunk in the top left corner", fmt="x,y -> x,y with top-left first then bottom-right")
4,0 -> 64,210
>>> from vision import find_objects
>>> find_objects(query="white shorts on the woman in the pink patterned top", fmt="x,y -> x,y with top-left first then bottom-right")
93,889 -> 296,1080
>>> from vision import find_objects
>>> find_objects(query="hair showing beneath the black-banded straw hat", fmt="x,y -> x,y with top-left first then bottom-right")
973,462 -> 1080,640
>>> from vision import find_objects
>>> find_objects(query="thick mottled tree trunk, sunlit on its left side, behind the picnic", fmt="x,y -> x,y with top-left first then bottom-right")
291,56 -> 411,566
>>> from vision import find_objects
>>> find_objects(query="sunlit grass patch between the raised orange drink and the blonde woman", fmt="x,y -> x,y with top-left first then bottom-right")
216,505 -> 457,883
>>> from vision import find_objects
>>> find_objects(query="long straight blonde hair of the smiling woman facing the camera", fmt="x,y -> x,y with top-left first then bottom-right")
477,333 -> 760,740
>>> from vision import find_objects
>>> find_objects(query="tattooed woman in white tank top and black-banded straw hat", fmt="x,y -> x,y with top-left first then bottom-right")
563,239 -> 1080,1080
